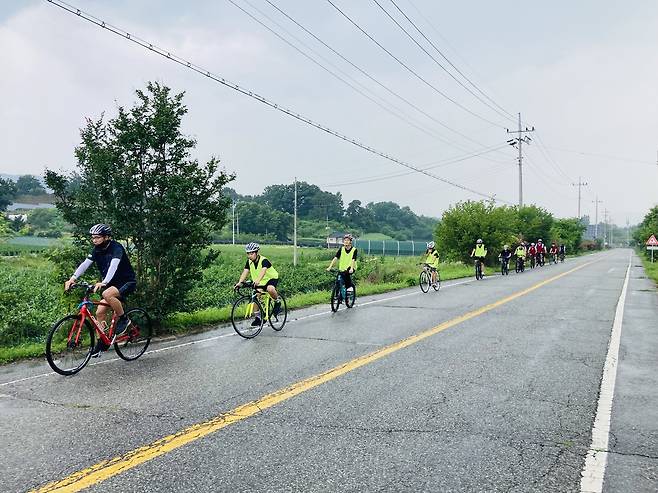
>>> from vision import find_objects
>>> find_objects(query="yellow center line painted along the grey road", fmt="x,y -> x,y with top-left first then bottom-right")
33,259 -> 600,493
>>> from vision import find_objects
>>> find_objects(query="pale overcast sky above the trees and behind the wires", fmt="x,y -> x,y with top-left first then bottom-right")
0,0 -> 658,225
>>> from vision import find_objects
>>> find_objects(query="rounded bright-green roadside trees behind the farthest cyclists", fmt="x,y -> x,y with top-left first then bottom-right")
435,201 -> 586,262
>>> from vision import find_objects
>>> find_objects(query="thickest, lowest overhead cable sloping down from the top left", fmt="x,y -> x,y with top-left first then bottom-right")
46,0 -> 505,202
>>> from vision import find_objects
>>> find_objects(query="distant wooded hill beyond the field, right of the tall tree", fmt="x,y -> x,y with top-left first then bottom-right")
224,182 -> 438,241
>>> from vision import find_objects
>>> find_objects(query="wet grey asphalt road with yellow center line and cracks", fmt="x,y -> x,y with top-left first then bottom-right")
0,250 -> 658,493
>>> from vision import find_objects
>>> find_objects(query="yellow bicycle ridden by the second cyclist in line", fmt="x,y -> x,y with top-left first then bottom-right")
231,281 -> 288,339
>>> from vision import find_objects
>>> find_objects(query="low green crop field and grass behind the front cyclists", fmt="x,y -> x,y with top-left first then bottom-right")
0,245 -> 471,363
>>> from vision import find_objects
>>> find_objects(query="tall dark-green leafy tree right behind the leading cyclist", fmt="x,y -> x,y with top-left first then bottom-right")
46,82 -> 233,318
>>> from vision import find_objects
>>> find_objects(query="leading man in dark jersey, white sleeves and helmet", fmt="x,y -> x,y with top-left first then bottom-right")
64,224 -> 137,357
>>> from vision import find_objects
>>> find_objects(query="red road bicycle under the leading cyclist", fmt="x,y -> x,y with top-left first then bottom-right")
46,283 -> 153,375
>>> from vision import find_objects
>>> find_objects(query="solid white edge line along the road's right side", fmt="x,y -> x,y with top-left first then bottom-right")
580,253 -> 632,493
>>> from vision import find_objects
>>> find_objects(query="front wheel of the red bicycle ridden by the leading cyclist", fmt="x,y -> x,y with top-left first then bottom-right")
46,315 -> 96,375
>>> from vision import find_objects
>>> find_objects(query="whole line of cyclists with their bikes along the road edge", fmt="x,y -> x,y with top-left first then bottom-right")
46,224 -> 565,375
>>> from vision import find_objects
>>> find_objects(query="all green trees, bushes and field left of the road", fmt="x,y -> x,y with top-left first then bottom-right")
0,83 -> 598,362
